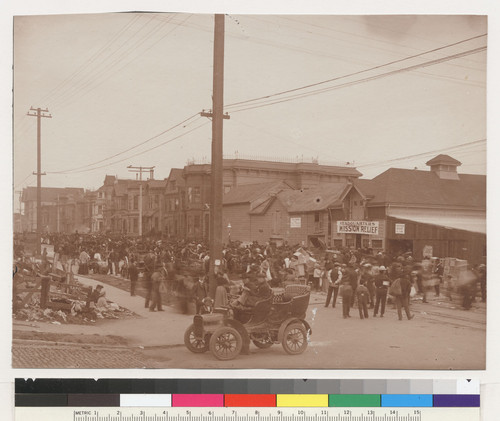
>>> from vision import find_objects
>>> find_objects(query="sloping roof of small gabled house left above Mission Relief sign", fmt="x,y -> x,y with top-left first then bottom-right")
278,183 -> 353,213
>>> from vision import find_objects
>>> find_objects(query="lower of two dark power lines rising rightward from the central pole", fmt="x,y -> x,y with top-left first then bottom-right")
227,47 -> 487,113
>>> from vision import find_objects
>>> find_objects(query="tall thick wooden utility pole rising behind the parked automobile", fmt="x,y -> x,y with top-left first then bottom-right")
200,14 -> 229,298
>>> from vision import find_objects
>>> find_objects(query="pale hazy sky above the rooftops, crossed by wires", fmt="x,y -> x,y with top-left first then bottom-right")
13,13 -> 488,199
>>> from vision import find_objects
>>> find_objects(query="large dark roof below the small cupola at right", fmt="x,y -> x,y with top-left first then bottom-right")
362,168 -> 486,209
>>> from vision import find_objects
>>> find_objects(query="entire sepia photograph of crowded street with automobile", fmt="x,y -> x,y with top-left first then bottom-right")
10,12 -> 488,370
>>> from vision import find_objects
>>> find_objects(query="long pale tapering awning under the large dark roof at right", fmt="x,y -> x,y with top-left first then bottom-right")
387,211 -> 486,234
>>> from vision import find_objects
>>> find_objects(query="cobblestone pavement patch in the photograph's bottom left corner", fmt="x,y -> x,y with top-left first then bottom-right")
12,341 -> 155,368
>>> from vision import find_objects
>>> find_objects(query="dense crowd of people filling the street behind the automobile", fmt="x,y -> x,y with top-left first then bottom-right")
14,232 -> 486,320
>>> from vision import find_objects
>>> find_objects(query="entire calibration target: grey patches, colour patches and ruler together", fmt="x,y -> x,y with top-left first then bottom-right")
15,379 -> 481,421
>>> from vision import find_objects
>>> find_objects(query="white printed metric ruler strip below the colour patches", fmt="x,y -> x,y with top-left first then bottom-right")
16,407 -> 480,421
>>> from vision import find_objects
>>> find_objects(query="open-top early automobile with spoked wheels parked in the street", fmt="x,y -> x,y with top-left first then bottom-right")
184,285 -> 312,360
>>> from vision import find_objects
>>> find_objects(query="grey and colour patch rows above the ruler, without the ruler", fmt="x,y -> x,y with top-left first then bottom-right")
15,379 -> 480,408
